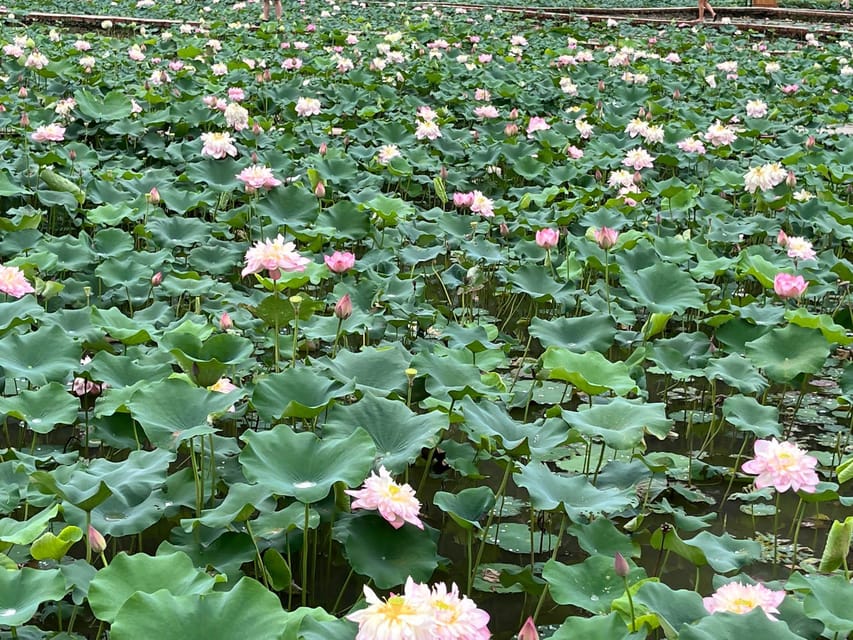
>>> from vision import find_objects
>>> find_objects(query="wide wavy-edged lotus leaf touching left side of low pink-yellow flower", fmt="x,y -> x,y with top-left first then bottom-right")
239,425 -> 376,503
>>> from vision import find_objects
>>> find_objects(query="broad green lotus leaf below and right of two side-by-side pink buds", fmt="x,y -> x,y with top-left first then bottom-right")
620,262 -> 705,314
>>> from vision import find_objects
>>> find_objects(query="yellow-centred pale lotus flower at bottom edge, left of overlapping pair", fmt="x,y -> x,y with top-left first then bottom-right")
347,578 -> 435,640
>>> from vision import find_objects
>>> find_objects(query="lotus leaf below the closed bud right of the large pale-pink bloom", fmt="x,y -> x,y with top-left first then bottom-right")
317,342 -> 412,396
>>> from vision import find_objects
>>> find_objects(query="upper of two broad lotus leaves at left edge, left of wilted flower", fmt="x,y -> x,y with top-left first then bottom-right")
0,325 -> 81,386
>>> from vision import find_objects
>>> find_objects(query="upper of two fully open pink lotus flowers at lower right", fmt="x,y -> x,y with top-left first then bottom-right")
741,438 -> 820,493
